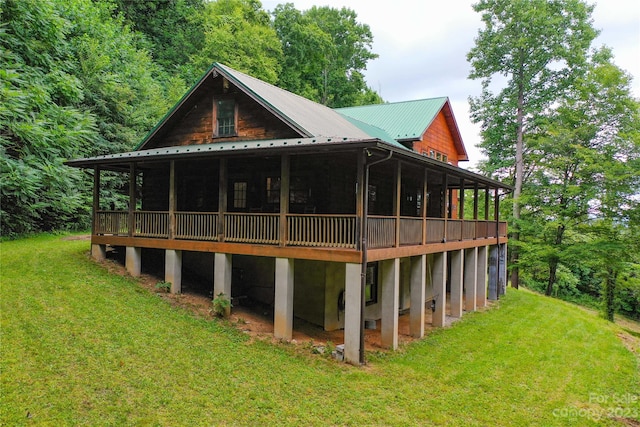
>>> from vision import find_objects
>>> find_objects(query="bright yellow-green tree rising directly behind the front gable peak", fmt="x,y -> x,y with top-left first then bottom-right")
190,0 -> 282,83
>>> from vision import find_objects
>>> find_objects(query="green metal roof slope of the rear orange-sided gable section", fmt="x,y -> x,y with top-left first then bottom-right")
335,97 -> 448,141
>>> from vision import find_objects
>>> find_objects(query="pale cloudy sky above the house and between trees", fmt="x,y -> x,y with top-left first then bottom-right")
262,0 -> 640,169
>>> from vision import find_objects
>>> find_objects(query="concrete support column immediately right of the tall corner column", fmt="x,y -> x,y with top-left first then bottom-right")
380,258 -> 400,350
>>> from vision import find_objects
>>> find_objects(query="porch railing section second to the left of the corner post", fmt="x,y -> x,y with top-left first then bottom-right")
224,213 -> 280,244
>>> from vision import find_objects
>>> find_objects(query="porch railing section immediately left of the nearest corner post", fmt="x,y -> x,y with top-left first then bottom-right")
287,215 -> 356,249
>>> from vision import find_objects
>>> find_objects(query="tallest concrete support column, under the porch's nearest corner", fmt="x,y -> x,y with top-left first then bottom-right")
344,263 -> 363,365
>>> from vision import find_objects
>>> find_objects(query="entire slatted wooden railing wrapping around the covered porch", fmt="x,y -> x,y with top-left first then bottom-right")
95,211 -> 507,249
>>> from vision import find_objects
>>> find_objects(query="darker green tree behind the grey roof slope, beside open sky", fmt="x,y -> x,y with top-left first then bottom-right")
273,3 -> 382,107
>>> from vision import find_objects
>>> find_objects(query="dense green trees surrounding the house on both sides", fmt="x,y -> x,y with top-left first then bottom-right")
0,0 -> 640,319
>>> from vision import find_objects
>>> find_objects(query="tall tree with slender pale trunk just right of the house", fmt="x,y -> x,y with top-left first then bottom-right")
467,0 -> 597,287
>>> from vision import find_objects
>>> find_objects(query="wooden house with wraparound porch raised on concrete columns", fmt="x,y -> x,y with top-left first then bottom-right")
67,64 -> 509,363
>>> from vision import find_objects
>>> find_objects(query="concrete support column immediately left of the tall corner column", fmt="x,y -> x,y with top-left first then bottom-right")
273,258 -> 293,341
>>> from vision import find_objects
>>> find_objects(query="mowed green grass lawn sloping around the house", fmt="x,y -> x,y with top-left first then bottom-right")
0,235 -> 640,426
